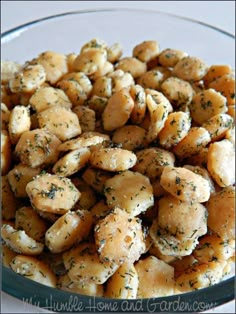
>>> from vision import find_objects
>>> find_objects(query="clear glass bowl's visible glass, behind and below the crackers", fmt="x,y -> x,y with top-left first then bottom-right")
1,9 -> 235,312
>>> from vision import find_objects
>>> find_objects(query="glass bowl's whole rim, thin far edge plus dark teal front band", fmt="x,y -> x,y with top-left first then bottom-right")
1,8 -> 235,313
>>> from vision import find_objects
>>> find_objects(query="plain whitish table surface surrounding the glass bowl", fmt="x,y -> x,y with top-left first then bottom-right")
1,1 -> 235,313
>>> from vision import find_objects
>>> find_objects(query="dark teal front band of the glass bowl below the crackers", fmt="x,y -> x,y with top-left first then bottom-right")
2,266 -> 235,313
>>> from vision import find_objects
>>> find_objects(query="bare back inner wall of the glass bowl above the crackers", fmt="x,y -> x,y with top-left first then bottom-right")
2,9 -> 235,68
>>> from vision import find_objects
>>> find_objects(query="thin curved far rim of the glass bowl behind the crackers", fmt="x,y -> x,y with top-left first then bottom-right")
1,7 -> 235,44
